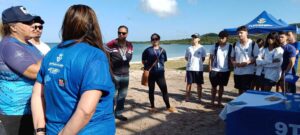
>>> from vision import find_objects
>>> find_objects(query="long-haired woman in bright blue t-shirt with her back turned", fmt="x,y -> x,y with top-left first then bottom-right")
31,5 -> 115,135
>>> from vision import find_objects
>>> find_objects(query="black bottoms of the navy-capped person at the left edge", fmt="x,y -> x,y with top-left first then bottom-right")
0,115 -> 34,135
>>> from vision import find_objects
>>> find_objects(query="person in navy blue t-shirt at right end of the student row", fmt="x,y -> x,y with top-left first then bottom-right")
279,32 -> 296,93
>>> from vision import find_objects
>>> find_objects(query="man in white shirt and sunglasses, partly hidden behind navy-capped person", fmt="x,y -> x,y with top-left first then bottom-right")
29,16 -> 50,56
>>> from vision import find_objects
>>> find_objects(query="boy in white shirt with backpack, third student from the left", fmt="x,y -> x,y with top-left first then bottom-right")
231,26 -> 259,94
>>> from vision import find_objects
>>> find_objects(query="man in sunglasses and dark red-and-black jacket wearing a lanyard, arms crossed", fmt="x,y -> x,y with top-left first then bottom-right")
107,25 -> 133,121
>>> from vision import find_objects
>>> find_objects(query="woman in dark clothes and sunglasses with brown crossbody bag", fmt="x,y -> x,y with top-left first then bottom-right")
142,33 -> 177,112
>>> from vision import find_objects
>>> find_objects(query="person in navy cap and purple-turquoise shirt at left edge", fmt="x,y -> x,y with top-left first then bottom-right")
0,6 -> 44,135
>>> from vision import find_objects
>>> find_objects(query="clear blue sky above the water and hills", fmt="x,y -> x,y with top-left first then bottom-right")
0,0 -> 300,43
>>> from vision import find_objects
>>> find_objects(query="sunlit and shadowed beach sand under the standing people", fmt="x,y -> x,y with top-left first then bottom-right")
116,59 -> 300,135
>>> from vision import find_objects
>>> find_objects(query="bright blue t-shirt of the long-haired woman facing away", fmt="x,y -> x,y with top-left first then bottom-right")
37,40 -> 115,135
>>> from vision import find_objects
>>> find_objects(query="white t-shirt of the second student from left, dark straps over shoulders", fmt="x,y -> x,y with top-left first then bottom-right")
210,43 -> 230,72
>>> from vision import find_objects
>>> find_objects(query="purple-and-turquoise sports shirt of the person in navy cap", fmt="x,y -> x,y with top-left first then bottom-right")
0,36 -> 42,115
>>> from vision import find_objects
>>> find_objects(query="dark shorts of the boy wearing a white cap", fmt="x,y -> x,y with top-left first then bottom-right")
186,71 -> 204,84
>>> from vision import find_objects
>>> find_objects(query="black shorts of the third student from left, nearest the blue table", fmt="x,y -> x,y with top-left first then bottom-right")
234,74 -> 254,90
